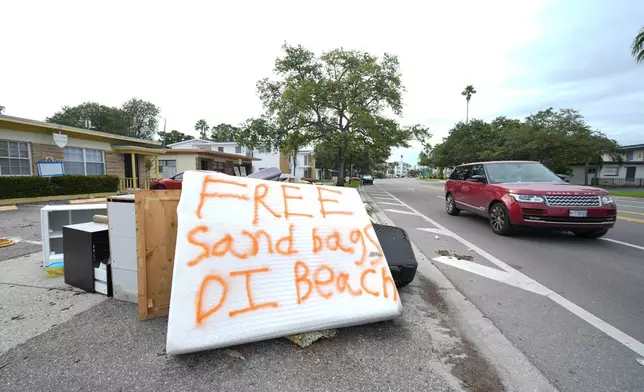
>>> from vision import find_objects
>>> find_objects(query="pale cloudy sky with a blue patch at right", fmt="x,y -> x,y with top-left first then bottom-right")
0,0 -> 644,165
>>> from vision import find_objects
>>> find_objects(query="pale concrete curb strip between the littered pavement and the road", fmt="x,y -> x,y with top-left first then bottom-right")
360,189 -> 558,392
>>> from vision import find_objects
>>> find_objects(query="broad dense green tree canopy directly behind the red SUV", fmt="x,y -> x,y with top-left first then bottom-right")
424,108 -> 619,181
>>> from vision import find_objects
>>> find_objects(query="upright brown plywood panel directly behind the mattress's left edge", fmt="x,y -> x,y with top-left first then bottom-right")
135,190 -> 181,320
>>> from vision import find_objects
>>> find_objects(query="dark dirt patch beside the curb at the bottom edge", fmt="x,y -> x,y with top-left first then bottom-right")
452,336 -> 505,392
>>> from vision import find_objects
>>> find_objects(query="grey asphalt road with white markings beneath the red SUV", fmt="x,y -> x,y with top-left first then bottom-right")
364,179 -> 644,392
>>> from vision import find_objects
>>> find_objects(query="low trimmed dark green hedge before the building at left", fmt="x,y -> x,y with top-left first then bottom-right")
0,175 -> 119,199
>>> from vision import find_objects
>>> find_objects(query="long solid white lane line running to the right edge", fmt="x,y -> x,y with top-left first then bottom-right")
372,188 -> 644,357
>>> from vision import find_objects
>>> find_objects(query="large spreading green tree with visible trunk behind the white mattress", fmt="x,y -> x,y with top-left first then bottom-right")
246,44 -> 428,185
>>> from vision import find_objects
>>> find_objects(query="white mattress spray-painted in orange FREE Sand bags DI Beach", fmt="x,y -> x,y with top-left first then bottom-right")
166,171 -> 402,354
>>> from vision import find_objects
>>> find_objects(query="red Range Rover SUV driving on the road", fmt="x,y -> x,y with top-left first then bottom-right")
445,161 -> 617,238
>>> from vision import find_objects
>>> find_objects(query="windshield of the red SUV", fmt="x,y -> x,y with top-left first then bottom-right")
485,162 -> 564,184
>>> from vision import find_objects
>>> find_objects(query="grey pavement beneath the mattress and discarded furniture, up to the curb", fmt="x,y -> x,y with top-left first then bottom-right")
0,202 -> 503,392
